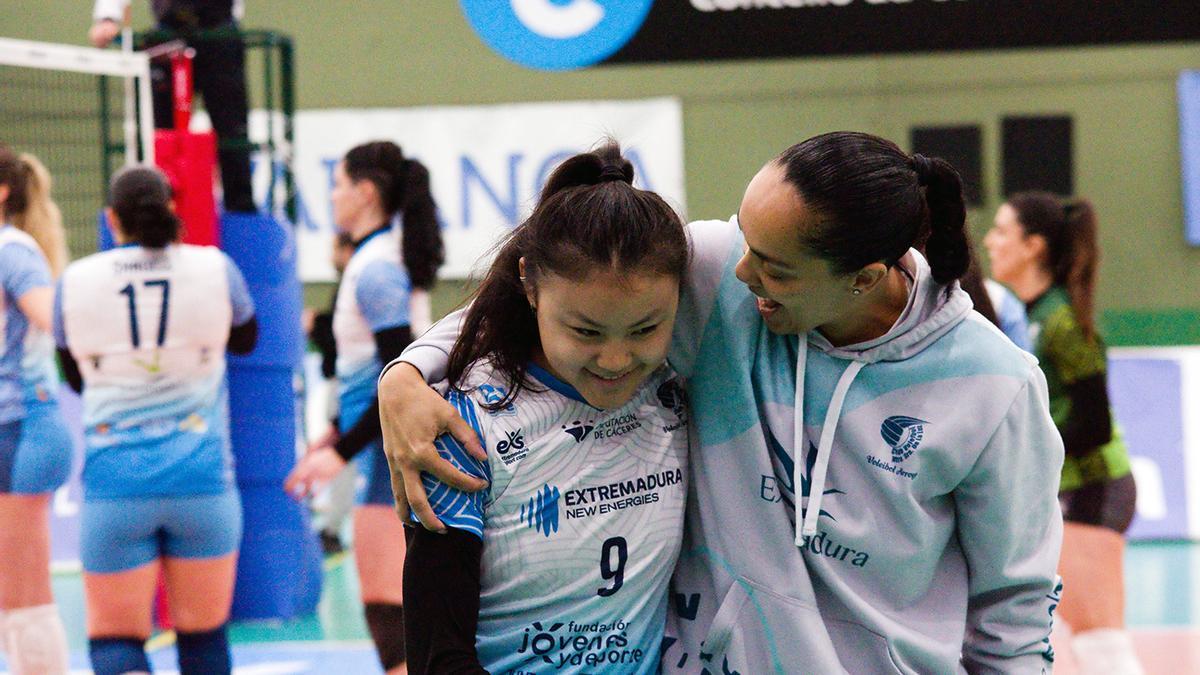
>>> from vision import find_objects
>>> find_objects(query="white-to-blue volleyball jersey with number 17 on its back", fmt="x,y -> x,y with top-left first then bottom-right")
54,244 -> 254,498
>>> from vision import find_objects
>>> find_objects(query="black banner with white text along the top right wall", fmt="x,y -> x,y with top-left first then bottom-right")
609,0 -> 1200,64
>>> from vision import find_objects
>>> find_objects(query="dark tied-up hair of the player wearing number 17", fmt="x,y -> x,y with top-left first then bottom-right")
108,166 -> 180,249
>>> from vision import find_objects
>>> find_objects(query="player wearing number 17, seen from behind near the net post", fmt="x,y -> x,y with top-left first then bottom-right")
54,167 -> 257,675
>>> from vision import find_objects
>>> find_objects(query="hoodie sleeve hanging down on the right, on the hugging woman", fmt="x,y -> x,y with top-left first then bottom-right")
955,366 -> 1063,673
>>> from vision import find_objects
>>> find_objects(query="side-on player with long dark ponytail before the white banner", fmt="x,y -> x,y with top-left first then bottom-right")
284,141 -> 443,673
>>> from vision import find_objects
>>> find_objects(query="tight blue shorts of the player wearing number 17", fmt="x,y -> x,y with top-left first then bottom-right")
79,490 -> 241,574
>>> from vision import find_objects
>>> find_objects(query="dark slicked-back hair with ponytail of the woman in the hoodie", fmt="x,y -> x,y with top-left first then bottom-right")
776,131 -> 971,289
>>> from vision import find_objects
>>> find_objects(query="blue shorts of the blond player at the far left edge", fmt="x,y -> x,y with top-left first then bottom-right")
6,396 -> 74,495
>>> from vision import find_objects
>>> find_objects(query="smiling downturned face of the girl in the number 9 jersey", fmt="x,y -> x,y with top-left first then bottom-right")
529,269 -> 679,408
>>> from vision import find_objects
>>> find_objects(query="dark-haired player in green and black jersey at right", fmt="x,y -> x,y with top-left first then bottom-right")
984,192 -> 1141,675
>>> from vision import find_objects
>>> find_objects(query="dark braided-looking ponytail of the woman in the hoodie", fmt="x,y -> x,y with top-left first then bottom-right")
912,154 -> 971,283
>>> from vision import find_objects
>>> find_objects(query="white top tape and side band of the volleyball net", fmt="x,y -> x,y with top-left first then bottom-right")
0,37 -> 154,166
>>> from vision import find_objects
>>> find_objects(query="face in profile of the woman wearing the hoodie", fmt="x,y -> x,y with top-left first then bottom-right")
734,162 -> 856,335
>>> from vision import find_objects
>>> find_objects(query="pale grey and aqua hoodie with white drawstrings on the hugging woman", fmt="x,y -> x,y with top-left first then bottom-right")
402,220 -> 1063,675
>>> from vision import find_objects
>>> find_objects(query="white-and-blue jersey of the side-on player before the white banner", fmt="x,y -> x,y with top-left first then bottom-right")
334,229 -> 410,415
